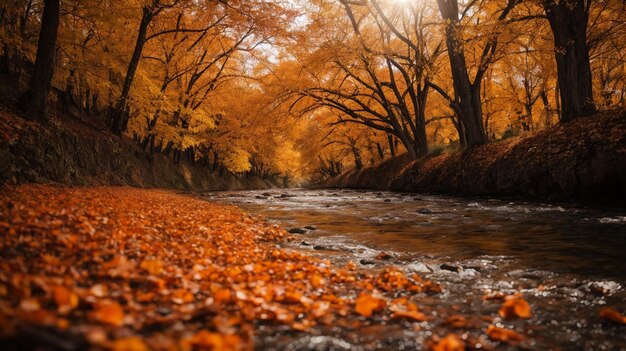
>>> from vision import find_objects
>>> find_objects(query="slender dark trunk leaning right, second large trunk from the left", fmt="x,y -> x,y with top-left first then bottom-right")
111,1 -> 156,135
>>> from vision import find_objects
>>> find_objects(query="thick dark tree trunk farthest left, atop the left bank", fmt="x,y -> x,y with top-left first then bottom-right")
18,0 -> 60,120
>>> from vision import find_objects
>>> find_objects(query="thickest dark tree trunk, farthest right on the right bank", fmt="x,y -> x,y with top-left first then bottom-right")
543,0 -> 596,122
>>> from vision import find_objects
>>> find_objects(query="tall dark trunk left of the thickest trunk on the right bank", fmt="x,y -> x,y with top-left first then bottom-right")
437,0 -> 487,147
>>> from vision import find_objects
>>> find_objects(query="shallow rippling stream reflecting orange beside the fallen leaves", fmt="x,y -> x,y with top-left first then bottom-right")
205,189 -> 626,350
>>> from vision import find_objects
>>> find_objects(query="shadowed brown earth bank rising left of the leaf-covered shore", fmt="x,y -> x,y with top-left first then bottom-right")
0,104 -> 276,190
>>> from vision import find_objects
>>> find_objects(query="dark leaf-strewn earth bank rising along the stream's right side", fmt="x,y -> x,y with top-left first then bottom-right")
323,111 -> 626,203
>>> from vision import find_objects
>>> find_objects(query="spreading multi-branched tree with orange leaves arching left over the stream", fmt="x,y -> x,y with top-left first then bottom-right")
290,0 -> 441,159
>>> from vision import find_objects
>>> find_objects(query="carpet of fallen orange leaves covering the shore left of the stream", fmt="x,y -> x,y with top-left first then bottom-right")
0,185 -> 626,351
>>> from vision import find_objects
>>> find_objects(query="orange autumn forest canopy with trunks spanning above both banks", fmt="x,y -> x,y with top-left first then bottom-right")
0,0 -> 626,181
